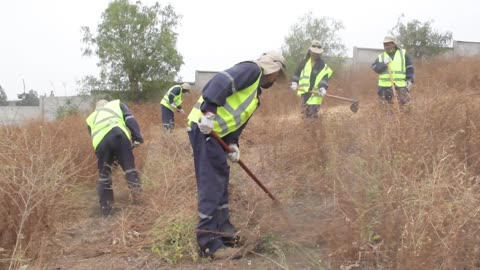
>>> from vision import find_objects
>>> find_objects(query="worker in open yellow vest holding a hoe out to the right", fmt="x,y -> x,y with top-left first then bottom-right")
290,40 -> 333,119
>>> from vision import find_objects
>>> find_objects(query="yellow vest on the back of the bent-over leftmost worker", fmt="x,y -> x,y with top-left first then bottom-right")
87,99 -> 131,149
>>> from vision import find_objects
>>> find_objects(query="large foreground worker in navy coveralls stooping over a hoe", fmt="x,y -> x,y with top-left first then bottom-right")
188,51 -> 285,259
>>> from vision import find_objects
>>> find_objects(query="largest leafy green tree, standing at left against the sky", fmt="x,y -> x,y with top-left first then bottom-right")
82,0 -> 183,100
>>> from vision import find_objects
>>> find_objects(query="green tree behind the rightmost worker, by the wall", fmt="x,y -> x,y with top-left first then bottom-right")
390,15 -> 452,59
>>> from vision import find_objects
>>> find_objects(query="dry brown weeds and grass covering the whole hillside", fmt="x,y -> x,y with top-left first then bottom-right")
0,59 -> 480,269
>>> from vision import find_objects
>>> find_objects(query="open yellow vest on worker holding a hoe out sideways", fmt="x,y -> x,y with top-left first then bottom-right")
297,58 -> 333,105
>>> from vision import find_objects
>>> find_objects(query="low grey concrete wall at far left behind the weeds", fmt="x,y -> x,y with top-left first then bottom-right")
0,96 -> 93,125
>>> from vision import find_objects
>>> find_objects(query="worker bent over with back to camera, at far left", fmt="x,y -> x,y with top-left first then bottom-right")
87,99 -> 143,217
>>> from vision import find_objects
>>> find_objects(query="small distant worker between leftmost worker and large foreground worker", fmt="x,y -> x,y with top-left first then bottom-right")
160,83 -> 192,132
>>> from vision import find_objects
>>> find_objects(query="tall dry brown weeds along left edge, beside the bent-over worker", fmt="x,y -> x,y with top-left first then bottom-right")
0,119 -> 94,269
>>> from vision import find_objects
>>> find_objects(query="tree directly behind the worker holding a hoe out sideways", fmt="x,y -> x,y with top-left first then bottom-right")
282,12 -> 346,74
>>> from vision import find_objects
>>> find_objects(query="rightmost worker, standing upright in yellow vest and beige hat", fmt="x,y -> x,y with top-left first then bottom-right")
372,36 -> 414,107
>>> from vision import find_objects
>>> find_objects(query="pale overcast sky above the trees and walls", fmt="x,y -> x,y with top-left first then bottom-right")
0,0 -> 480,99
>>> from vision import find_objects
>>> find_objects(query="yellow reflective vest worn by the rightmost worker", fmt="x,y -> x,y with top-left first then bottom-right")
378,49 -> 407,87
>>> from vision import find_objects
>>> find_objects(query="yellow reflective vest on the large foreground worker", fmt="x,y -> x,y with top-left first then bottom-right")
188,73 -> 262,137
